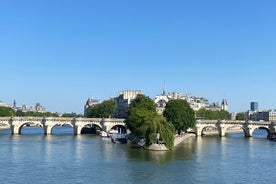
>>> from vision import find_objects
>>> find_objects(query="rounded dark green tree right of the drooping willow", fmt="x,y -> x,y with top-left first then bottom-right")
163,99 -> 195,133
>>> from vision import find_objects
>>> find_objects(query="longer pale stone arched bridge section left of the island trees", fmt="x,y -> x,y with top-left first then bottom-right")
0,117 -> 125,135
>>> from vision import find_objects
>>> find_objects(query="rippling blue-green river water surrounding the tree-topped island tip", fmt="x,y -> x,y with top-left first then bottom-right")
0,127 -> 276,184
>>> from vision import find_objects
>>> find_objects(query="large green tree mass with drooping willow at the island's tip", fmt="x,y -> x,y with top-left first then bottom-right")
125,94 -> 175,149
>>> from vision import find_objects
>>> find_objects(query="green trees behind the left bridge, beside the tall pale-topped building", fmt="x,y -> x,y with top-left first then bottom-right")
87,99 -> 117,118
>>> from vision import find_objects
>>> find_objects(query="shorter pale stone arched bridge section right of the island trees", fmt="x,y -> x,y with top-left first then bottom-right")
194,120 -> 276,137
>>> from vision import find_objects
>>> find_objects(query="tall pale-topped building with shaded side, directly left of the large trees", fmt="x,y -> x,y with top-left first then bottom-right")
115,90 -> 142,118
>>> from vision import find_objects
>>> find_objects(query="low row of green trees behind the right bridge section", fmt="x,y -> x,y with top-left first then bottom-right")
196,108 -> 231,120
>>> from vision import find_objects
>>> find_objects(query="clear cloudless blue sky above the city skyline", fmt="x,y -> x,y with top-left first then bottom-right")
0,0 -> 276,113
